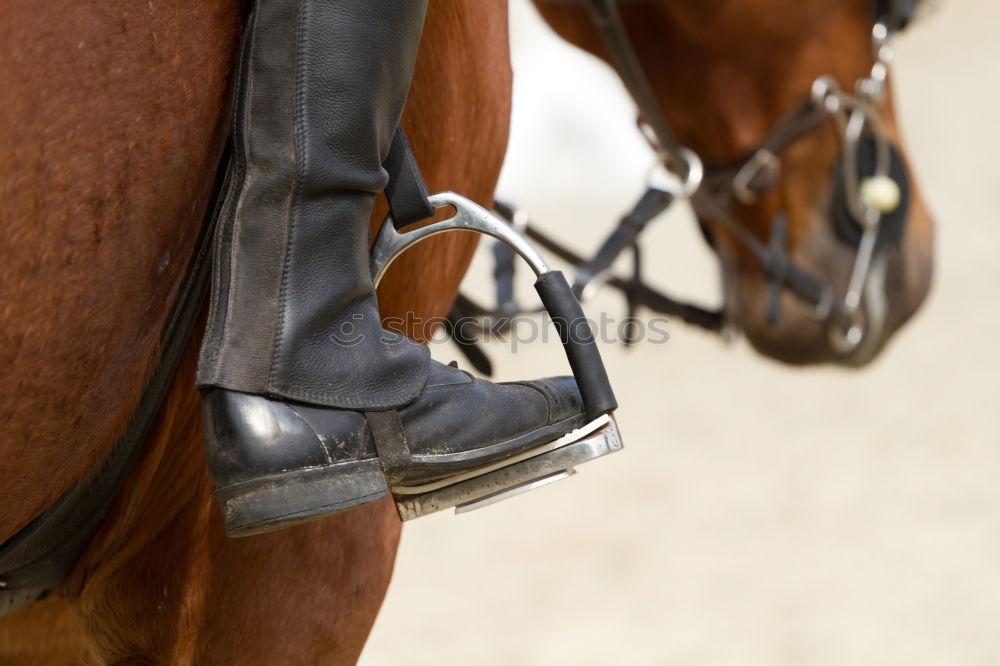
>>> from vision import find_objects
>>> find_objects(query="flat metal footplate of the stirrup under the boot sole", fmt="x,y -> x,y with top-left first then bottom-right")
392,415 -> 622,520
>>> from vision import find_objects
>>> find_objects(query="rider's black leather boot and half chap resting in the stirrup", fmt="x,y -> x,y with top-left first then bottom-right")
198,0 -> 612,535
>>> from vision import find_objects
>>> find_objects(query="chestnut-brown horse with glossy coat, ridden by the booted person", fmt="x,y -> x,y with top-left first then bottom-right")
0,0 -> 930,664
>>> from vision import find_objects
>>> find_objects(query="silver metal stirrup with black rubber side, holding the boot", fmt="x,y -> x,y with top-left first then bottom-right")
370,192 -> 622,521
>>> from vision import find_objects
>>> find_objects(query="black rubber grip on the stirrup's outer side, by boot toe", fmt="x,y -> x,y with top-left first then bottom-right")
535,271 -> 618,419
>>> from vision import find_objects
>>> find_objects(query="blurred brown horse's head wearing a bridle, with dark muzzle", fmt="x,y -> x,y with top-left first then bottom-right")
536,0 -> 933,365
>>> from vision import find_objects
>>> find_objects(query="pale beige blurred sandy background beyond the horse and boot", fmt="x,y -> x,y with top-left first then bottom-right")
361,0 -> 1000,666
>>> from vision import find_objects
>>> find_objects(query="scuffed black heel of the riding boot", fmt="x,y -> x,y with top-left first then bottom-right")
215,459 -> 389,537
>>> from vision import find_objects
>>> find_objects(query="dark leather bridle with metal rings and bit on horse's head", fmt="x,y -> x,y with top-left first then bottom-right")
452,0 -> 919,366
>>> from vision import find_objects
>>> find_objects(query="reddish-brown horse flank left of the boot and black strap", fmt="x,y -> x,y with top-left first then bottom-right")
0,0 -> 240,539
